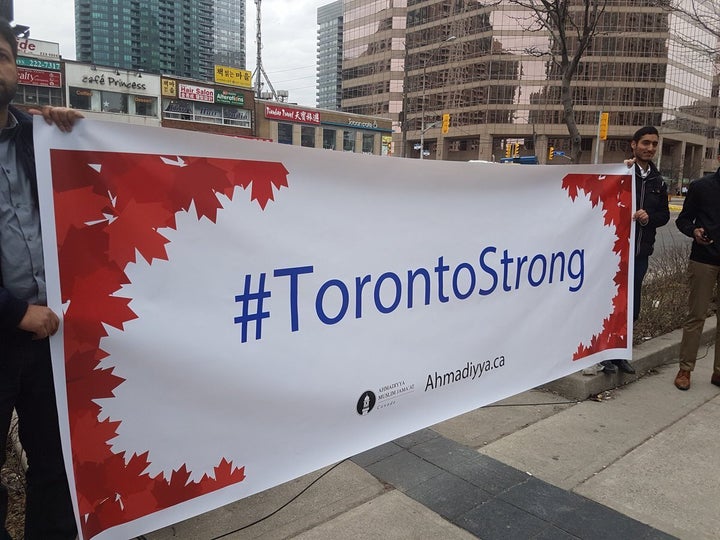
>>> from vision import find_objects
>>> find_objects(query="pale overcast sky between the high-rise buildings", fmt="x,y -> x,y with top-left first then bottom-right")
15,0 -> 331,106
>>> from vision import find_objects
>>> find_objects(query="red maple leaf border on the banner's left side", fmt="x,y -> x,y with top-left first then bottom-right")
51,150 -> 288,537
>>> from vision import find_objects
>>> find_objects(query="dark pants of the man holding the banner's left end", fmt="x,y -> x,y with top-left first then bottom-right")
0,335 -> 77,540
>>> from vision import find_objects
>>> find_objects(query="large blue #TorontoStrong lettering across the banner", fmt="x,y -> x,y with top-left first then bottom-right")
234,246 -> 585,343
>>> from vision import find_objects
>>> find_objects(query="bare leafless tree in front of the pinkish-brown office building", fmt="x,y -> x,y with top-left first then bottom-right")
508,0 -> 608,162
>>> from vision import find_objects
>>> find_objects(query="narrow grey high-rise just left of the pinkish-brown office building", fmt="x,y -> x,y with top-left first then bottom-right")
317,0 -> 343,110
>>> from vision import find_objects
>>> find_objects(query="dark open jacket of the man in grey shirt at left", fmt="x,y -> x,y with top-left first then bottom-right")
0,107 -> 37,332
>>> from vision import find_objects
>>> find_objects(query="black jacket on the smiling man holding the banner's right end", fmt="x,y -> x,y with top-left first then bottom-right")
635,162 -> 670,257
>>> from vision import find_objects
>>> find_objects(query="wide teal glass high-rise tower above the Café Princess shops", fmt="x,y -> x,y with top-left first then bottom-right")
75,0 -> 245,79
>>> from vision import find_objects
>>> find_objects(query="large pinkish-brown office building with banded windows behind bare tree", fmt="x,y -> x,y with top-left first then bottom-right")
342,0 -> 717,179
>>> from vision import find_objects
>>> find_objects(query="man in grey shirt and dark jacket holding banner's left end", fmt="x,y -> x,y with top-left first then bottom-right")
0,20 -> 82,540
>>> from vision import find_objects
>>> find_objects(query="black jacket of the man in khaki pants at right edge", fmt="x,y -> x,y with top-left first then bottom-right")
675,169 -> 720,266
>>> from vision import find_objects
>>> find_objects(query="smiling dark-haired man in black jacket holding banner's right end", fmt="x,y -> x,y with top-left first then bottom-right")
601,126 -> 670,373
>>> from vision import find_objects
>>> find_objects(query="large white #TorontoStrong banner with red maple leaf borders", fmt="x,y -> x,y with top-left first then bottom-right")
35,120 -> 633,539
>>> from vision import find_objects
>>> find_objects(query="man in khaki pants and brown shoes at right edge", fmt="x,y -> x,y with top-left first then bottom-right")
675,156 -> 720,390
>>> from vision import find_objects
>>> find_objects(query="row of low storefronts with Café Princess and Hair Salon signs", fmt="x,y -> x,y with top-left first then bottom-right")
13,39 -> 392,155
